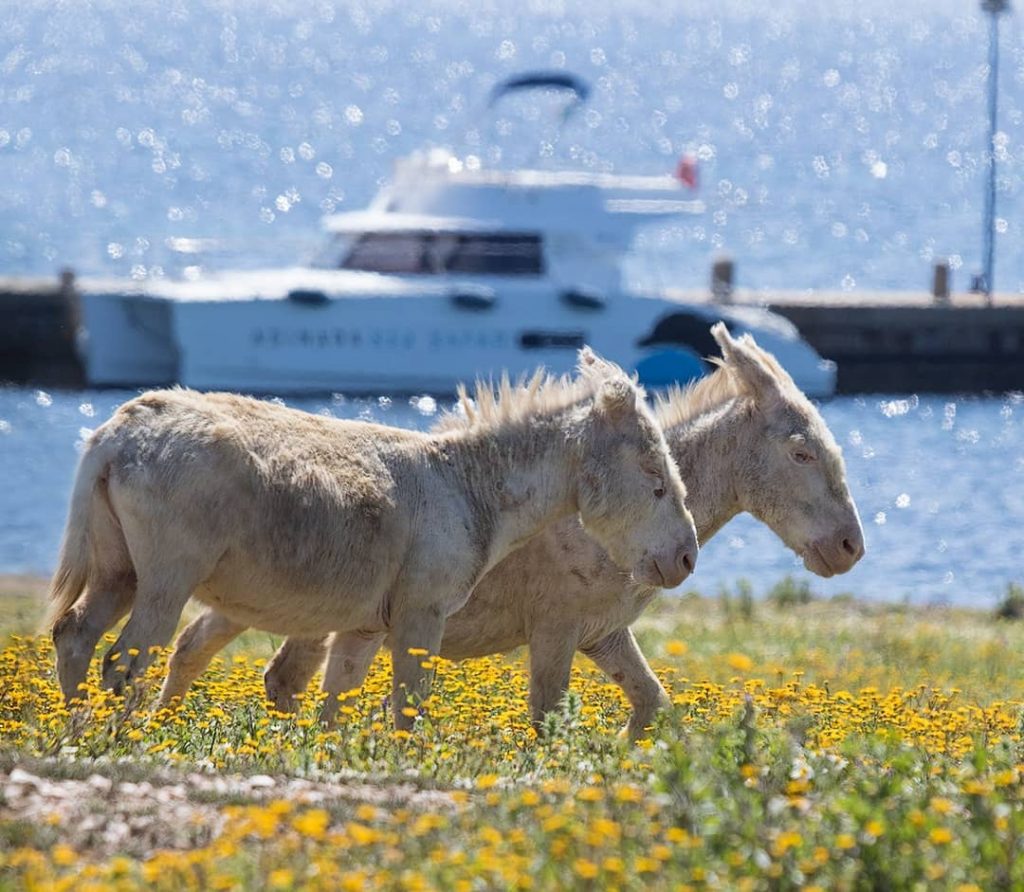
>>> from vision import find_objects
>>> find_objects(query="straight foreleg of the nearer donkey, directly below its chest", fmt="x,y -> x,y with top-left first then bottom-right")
391,604 -> 445,731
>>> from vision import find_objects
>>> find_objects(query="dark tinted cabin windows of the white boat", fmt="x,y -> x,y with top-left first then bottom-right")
340,232 -> 544,275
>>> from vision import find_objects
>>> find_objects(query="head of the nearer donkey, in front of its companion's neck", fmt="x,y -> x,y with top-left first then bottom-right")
577,347 -> 697,588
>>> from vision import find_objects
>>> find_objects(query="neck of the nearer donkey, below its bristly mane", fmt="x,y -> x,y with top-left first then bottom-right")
440,411 -> 579,571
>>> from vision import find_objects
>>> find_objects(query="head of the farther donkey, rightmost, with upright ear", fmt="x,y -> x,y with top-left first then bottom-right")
712,323 -> 864,577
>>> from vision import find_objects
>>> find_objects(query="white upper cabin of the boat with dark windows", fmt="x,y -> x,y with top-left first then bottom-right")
315,153 -> 702,289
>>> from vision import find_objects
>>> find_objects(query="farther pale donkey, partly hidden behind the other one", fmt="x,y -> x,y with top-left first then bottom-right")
159,325 -> 864,736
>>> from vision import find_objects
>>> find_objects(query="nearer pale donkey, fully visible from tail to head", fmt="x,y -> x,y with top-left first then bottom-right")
51,349 -> 696,727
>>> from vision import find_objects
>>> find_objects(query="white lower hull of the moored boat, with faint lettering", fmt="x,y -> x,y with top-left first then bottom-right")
77,272 -> 835,396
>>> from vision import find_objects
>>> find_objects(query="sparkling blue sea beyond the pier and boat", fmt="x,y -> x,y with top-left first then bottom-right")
0,0 -> 1024,292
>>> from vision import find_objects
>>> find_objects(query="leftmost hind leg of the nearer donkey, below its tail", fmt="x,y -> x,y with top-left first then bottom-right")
53,572 -> 135,703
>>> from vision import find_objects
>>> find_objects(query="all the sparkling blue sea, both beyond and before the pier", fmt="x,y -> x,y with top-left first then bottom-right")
0,0 -> 1024,604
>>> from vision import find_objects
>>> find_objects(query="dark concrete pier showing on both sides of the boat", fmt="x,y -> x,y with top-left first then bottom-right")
0,273 -> 1024,393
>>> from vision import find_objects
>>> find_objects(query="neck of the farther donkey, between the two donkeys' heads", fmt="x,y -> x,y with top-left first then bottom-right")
666,398 -> 745,545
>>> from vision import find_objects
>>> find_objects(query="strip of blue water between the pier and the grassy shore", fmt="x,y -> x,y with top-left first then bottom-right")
0,388 -> 1024,605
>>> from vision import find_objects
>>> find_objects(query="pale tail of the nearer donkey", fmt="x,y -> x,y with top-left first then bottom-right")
47,438 -> 123,631
